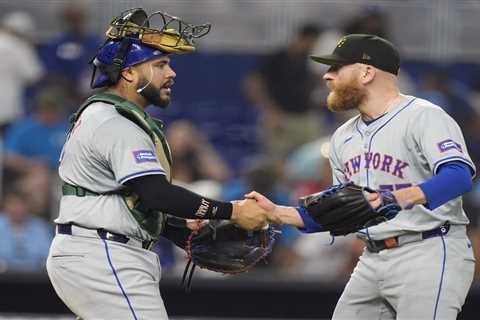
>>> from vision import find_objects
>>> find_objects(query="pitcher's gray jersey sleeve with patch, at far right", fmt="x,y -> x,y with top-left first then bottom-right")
413,107 -> 476,176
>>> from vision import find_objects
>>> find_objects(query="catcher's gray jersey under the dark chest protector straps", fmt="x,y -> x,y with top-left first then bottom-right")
55,102 -> 165,240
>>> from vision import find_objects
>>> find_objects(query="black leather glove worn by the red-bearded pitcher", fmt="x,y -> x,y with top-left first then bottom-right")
300,182 -> 402,236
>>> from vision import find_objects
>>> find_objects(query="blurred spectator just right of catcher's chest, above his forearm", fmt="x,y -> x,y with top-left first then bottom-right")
166,121 -> 231,197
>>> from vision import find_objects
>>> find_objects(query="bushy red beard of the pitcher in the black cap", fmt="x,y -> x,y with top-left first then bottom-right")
327,71 -> 366,112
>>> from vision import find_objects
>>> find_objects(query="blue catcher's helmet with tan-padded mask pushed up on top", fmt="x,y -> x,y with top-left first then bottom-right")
90,8 -> 211,88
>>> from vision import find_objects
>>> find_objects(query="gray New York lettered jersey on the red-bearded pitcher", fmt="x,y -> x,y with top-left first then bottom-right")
330,96 -> 475,239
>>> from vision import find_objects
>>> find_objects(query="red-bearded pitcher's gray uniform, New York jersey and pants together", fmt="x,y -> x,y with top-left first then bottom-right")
330,96 -> 475,320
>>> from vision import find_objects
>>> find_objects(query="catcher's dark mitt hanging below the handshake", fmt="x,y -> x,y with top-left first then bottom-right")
182,220 -> 277,291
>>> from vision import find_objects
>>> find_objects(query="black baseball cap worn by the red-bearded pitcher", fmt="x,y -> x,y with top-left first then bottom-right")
310,34 -> 400,75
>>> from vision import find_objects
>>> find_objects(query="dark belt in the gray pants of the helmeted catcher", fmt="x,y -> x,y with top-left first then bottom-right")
57,223 -> 155,250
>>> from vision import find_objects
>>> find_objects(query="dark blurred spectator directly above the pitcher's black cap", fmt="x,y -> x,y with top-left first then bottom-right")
344,6 -> 391,40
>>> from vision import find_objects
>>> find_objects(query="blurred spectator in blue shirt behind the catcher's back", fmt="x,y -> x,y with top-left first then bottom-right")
5,87 -> 69,171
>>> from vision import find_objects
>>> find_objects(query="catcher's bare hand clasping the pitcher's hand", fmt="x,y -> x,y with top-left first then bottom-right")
231,199 -> 267,230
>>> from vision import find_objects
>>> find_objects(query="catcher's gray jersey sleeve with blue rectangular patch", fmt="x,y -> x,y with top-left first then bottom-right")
95,118 -> 165,184
